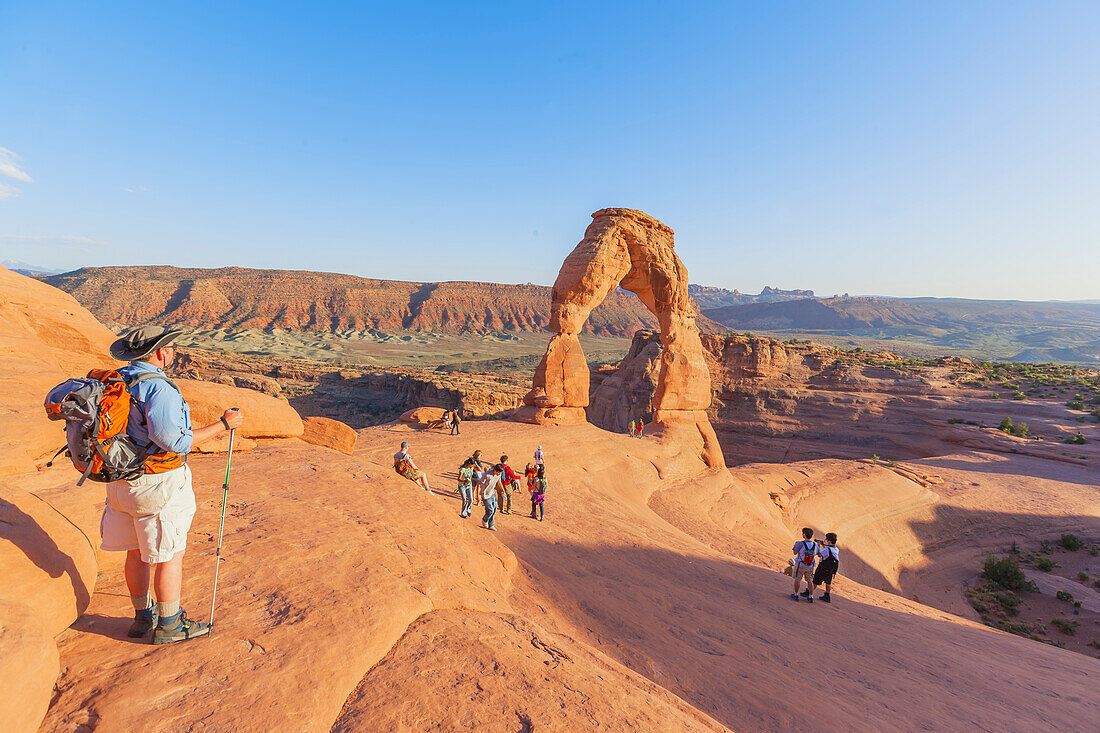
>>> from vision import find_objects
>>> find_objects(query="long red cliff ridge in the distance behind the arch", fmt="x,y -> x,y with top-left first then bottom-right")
44,266 -> 657,337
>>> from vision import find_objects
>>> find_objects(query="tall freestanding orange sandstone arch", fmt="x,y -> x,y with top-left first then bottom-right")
516,209 -> 725,468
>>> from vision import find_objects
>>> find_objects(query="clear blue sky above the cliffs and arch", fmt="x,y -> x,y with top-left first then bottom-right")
0,1 -> 1100,299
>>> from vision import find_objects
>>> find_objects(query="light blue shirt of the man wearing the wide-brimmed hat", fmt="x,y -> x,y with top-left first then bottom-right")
119,361 -> 194,456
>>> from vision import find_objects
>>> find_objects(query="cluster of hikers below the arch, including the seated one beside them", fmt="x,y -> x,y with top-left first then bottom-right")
394,440 -> 548,532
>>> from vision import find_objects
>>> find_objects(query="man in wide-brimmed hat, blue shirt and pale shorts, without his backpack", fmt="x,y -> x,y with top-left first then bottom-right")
100,326 -> 242,644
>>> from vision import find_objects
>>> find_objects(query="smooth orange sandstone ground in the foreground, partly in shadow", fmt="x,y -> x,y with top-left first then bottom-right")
42,422 -> 1100,731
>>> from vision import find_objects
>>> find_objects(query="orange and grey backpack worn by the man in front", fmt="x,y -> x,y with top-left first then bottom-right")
44,369 -> 184,486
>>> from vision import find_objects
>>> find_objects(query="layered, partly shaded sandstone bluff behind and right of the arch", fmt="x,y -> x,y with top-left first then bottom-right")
589,332 -> 1100,464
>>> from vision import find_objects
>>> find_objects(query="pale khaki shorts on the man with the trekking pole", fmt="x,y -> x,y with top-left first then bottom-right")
99,466 -> 196,562
